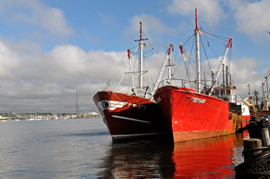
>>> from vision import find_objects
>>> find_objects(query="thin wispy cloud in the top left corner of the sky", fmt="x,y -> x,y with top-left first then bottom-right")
0,0 -> 73,36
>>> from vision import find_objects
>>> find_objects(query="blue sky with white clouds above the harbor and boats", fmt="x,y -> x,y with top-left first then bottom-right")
0,0 -> 270,113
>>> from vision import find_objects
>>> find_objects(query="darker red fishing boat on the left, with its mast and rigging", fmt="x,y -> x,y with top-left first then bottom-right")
93,23 -> 172,141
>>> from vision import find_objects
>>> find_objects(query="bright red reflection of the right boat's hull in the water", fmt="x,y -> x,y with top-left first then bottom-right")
173,135 -> 243,178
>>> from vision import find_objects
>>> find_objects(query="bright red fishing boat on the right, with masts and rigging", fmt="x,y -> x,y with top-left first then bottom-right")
154,9 -> 245,142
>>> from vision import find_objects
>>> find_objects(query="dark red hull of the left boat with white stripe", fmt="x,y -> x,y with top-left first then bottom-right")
93,91 -> 172,141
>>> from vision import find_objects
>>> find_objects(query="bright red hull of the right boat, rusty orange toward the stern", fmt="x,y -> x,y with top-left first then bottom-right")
154,86 -> 238,142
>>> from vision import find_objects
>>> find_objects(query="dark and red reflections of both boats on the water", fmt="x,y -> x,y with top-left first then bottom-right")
97,134 -> 243,178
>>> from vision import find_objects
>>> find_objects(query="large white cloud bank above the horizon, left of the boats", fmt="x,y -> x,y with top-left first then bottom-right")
0,41 -> 123,112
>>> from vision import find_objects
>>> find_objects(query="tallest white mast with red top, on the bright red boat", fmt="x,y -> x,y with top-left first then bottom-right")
194,8 -> 201,93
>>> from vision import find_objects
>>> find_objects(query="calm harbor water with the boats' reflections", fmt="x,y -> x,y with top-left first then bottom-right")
0,118 -> 243,178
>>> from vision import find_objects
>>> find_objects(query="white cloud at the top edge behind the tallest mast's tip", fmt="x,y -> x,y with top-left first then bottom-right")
167,0 -> 223,26
